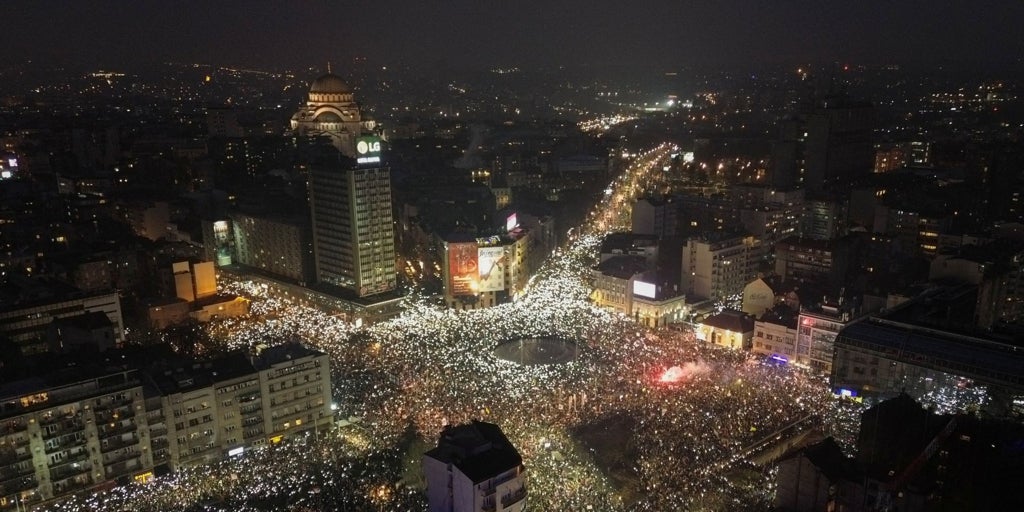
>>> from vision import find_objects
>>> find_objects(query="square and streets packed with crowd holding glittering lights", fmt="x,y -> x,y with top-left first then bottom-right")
41,145 -> 855,511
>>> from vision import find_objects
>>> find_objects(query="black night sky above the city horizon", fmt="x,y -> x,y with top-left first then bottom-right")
0,0 -> 1024,69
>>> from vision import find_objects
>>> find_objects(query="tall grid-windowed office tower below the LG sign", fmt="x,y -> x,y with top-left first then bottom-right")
309,159 -> 397,297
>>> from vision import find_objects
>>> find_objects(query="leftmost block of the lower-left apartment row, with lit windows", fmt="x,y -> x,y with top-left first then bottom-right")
0,368 -> 154,507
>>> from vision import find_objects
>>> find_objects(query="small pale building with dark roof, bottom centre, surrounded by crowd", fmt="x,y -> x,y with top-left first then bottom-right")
423,421 -> 526,512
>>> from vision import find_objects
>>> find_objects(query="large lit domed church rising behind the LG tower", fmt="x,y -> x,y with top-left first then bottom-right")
291,67 -> 375,158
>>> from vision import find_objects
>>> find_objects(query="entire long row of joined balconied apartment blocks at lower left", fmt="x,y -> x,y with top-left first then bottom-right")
0,344 -> 333,508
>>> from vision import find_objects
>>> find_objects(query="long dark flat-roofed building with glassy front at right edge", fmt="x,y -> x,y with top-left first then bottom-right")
831,286 -> 1024,416
